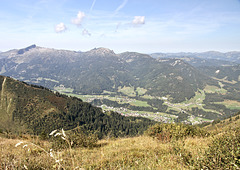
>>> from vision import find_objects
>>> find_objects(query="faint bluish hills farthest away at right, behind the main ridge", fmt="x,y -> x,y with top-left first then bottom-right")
151,51 -> 240,97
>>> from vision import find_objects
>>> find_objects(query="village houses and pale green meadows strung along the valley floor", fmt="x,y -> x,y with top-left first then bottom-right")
55,85 -> 213,125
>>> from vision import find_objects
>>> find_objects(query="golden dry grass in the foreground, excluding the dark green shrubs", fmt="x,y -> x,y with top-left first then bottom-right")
0,136 -> 211,169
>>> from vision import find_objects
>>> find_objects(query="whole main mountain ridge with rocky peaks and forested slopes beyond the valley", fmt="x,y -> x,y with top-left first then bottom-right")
0,45 -> 217,102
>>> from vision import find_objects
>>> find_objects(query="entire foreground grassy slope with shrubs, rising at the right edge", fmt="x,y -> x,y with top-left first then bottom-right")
0,112 -> 240,169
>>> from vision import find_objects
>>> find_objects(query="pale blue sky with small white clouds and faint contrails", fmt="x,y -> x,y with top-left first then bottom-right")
0,0 -> 240,53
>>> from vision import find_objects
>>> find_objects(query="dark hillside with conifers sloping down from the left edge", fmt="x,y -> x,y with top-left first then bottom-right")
0,76 -> 154,138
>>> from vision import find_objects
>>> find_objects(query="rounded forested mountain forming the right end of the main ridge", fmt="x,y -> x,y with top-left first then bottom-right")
119,52 -> 217,102
